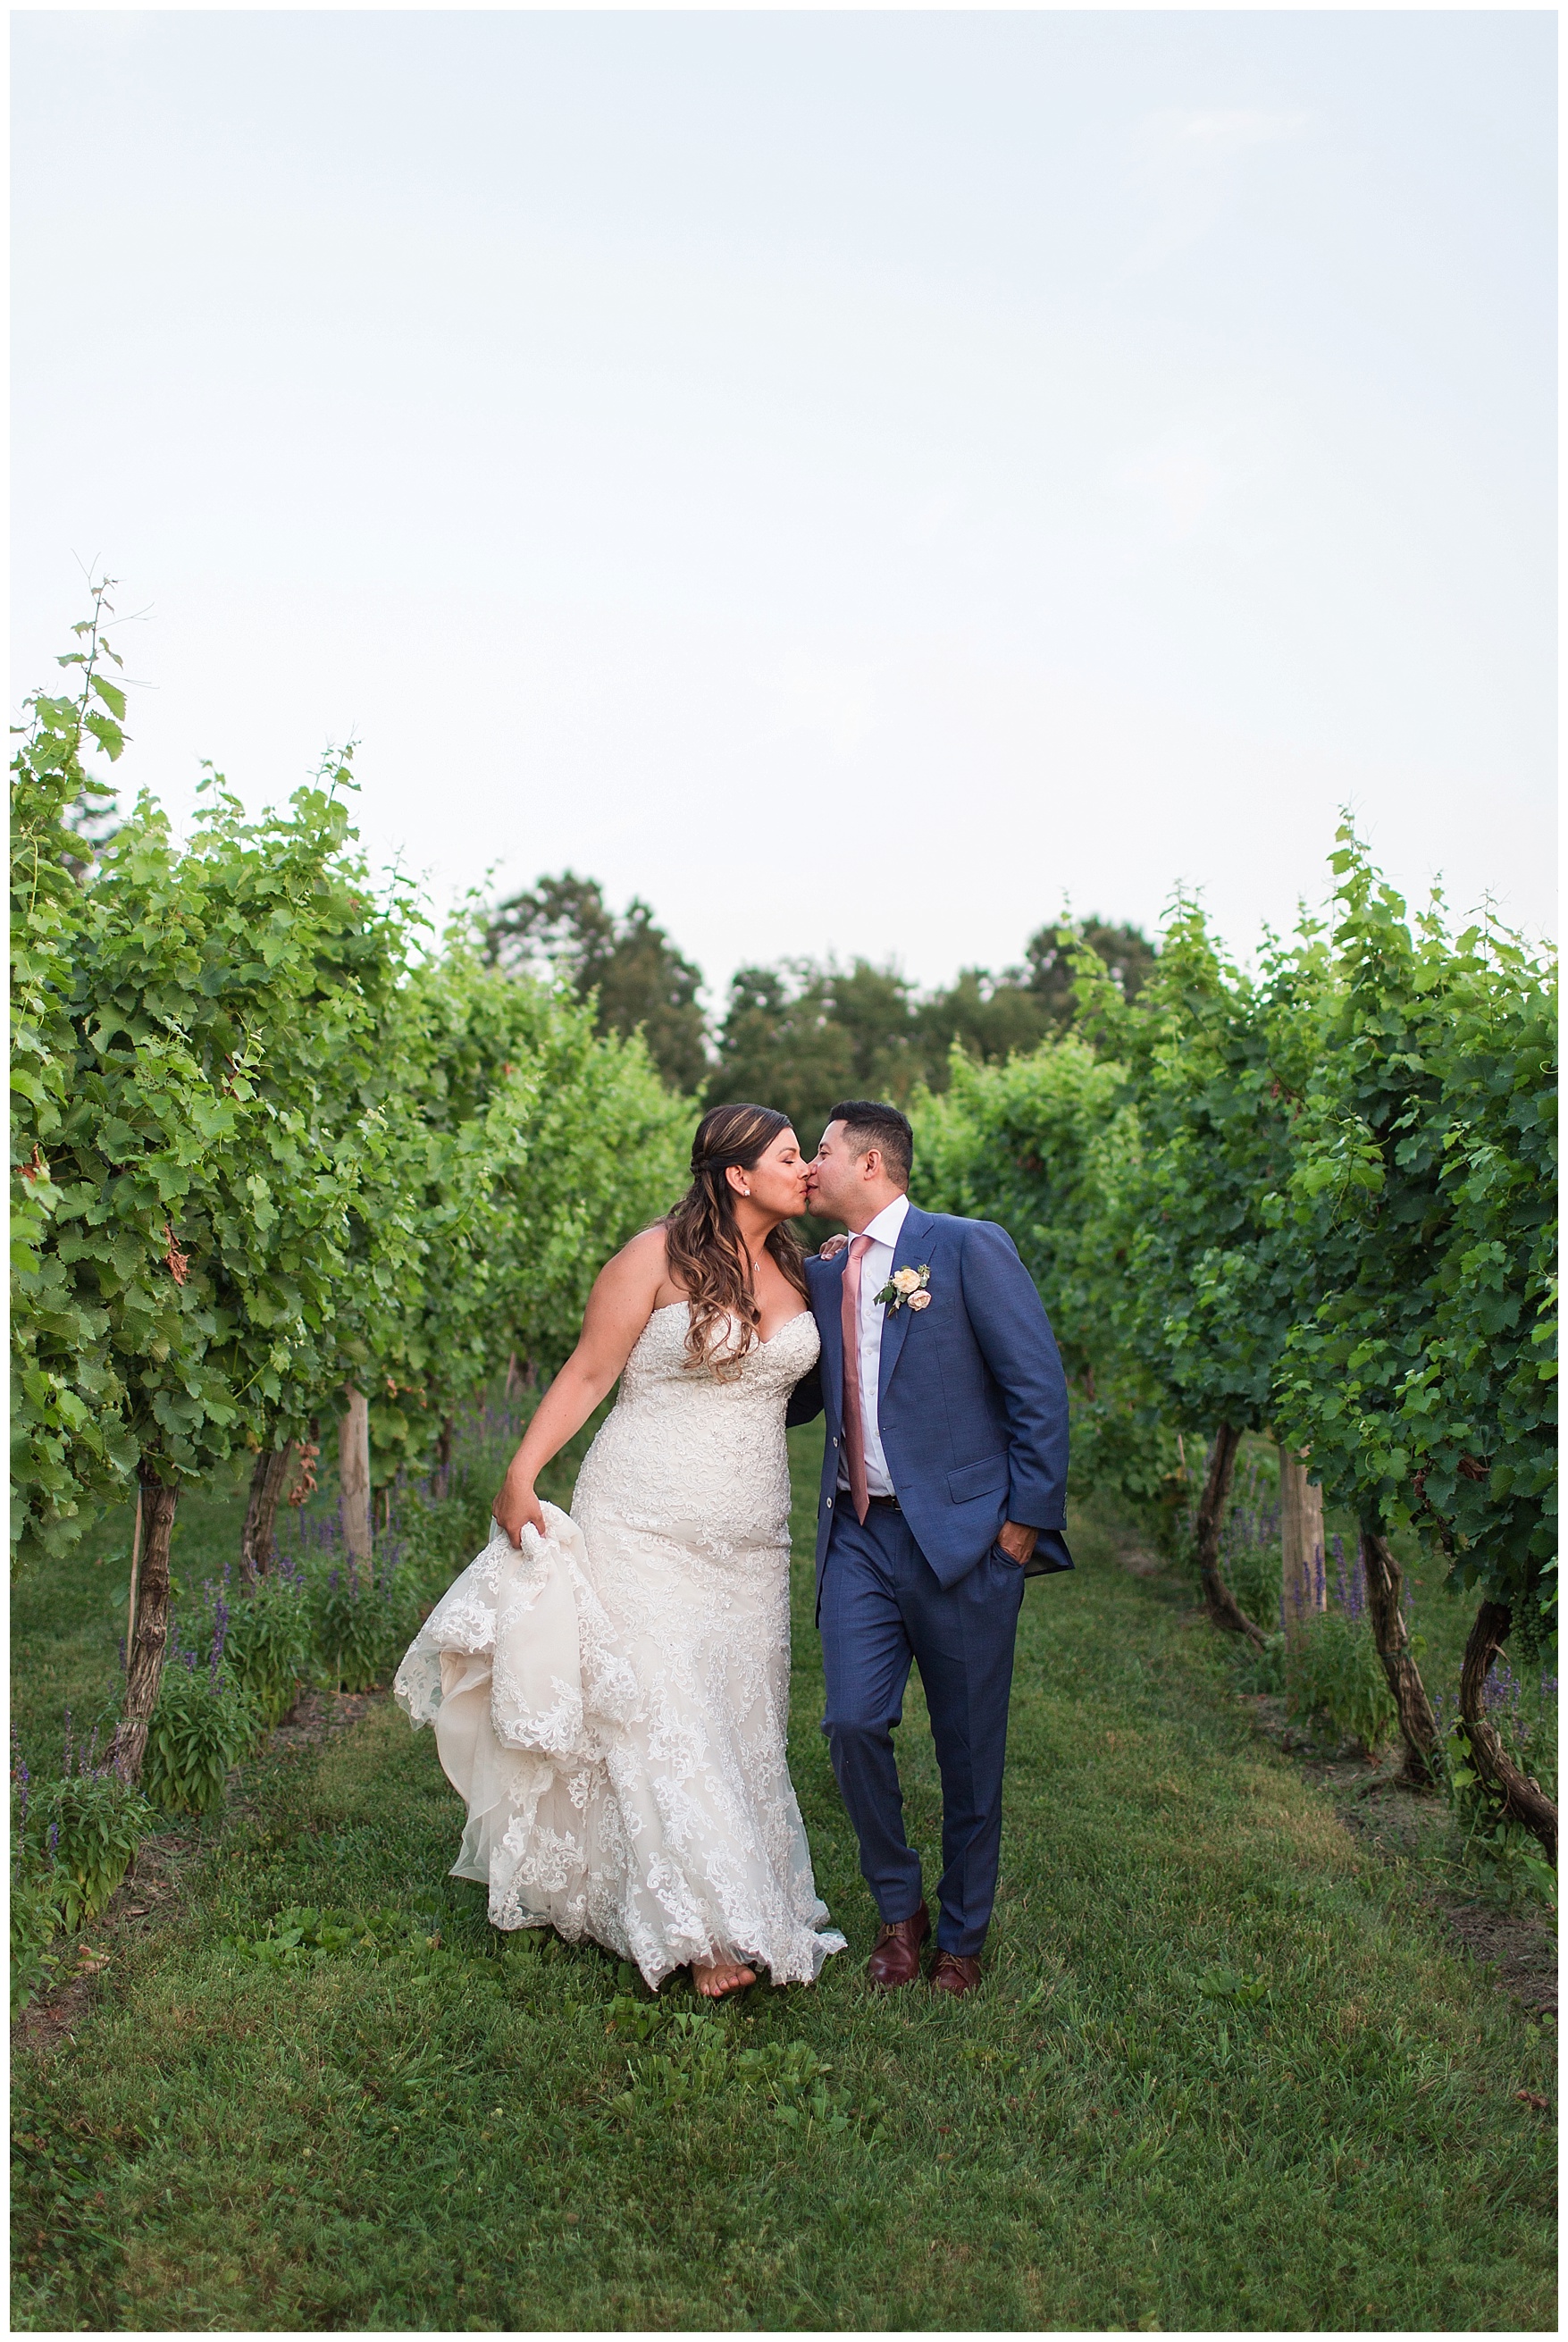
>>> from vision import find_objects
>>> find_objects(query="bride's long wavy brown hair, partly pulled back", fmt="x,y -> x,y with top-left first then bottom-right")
665,1105 -> 809,1380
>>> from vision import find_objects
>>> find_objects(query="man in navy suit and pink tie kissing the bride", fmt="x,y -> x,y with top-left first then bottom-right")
789,1098 -> 1072,1993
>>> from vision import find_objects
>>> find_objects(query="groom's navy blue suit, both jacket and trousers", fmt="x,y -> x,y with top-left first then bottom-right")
789,1206 -> 1072,1958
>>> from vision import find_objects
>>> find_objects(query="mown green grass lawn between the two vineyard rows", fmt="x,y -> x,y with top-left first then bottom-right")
12,1429 -> 1556,2330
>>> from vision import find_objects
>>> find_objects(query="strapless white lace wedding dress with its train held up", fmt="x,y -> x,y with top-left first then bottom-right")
393,1302 -> 845,1986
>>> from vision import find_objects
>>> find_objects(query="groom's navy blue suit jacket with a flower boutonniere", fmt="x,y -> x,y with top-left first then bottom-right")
789,1204 -> 1072,1588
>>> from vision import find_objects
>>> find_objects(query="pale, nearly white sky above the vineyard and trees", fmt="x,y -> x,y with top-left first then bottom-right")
12,14 -> 1556,1007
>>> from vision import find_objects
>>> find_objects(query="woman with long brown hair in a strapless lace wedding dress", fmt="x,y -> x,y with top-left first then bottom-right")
393,1105 -> 845,2000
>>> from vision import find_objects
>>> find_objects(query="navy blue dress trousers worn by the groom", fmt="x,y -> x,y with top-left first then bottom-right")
819,1498 -> 1025,1958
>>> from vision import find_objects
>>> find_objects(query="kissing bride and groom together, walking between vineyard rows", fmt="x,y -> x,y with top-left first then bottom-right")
396,1098 -> 1072,2000
